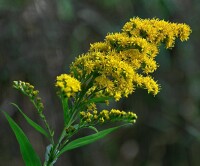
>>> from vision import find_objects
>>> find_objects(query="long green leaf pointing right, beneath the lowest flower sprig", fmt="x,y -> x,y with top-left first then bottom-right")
58,125 -> 127,157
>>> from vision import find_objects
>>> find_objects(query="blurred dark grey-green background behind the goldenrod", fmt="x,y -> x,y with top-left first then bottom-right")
0,0 -> 200,166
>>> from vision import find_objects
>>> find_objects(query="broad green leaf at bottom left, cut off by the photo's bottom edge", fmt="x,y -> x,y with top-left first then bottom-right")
3,112 -> 42,166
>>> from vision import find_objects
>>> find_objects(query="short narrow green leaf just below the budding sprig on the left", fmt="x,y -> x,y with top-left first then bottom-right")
11,103 -> 49,138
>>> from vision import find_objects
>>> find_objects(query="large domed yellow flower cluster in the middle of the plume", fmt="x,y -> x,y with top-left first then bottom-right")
75,52 -> 136,100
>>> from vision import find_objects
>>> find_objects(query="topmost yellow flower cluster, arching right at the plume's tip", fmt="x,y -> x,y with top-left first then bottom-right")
122,17 -> 191,48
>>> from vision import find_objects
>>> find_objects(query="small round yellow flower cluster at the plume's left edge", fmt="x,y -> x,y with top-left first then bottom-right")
55,74 -> 81,97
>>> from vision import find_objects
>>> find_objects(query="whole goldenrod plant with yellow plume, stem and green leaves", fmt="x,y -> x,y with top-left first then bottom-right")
4,17 -> 191,166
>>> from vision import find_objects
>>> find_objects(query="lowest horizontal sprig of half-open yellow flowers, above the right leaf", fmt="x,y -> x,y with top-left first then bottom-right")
80,109 -> 137,125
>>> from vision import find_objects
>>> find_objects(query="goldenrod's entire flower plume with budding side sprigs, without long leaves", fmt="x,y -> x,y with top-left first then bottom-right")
14,17 -> 191,133
